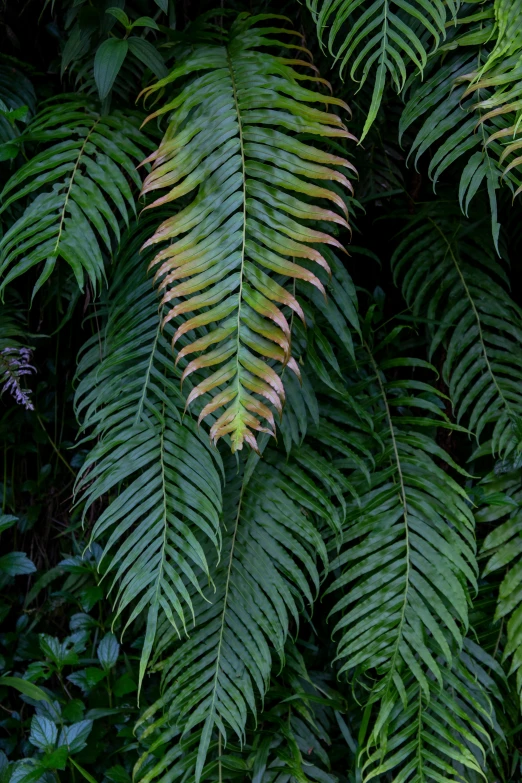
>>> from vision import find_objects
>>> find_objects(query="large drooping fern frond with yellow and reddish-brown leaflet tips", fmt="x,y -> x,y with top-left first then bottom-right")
136,15 -> 353,450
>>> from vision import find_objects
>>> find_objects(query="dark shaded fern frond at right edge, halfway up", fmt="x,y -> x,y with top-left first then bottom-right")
392,211 -> 522,455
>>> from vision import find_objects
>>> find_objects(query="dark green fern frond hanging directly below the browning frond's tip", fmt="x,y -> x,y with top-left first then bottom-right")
132,454 -> 326,780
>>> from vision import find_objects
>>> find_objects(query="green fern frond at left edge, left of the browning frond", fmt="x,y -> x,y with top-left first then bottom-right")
0,95 -> 151,295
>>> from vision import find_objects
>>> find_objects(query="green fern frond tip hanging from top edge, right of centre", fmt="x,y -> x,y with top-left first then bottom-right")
307,0 -> 450,141
